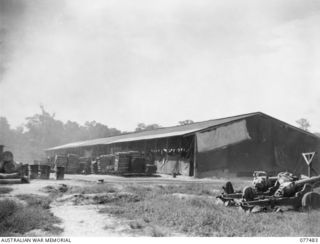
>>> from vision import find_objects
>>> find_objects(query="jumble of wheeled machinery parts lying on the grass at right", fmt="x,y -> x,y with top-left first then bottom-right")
217,171 -> 320,212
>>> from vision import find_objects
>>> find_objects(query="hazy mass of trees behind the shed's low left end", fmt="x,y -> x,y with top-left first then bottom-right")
0,107 -> 121,163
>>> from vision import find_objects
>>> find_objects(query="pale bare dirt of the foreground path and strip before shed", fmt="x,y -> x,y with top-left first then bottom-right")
3,175 -> 232,236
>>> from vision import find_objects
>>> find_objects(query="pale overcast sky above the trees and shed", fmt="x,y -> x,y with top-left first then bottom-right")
0,0 -> 320,131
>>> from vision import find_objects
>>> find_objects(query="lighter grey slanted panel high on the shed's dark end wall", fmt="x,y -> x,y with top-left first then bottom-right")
196,120 -> 251,152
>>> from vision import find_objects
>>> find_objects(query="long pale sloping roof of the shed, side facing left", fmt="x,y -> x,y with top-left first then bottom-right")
46,112 -> 262,151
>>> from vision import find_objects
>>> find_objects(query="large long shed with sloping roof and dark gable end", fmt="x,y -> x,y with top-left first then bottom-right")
46,112 -> 320,177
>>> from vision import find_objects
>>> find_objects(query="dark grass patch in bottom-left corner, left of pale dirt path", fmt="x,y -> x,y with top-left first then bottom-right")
0,195 -> 62,236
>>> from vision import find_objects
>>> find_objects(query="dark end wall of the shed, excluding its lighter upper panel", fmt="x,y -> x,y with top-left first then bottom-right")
197,115 -> 320,177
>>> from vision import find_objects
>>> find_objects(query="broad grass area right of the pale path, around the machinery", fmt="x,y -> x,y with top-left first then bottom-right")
97,182 -> 320,236
